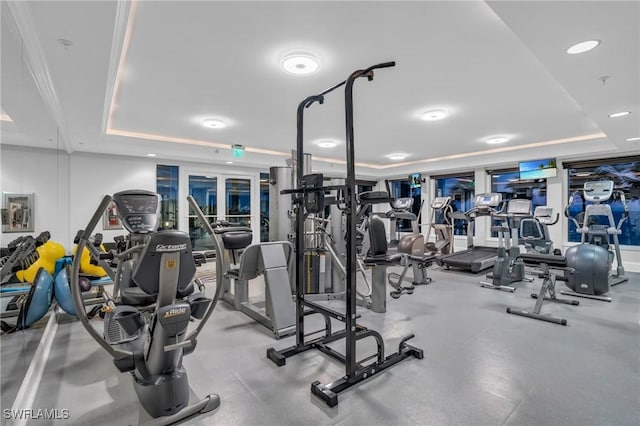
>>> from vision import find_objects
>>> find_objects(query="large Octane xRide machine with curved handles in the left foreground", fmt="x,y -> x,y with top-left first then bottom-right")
71,190 -> 220,425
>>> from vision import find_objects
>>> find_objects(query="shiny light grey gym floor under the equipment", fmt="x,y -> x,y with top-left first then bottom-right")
2,262 -> 640,426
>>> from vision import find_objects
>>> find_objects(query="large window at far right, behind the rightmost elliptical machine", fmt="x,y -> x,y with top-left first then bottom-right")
565,157 -> 640,246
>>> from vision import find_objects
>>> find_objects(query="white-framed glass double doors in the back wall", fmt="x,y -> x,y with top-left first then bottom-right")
188,174 -> 254,250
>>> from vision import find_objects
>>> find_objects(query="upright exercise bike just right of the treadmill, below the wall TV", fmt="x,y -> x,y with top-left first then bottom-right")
480,198 -> 533,293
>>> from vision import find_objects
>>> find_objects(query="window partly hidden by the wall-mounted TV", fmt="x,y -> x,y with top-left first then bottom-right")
491,169 -> 547,237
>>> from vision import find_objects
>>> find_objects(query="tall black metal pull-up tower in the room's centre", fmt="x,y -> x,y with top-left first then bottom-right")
267,62 -> 424,407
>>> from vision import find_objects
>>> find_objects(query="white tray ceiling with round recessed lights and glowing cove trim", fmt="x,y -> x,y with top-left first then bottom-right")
0,1 -> 640,177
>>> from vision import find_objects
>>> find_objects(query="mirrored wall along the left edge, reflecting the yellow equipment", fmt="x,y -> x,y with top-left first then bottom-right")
0,2 -> 69,407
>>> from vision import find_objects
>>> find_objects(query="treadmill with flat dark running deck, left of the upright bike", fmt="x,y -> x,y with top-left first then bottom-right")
436,192 -> 502,273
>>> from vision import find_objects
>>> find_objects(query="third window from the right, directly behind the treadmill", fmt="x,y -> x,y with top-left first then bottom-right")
434,173 -> 475,235
